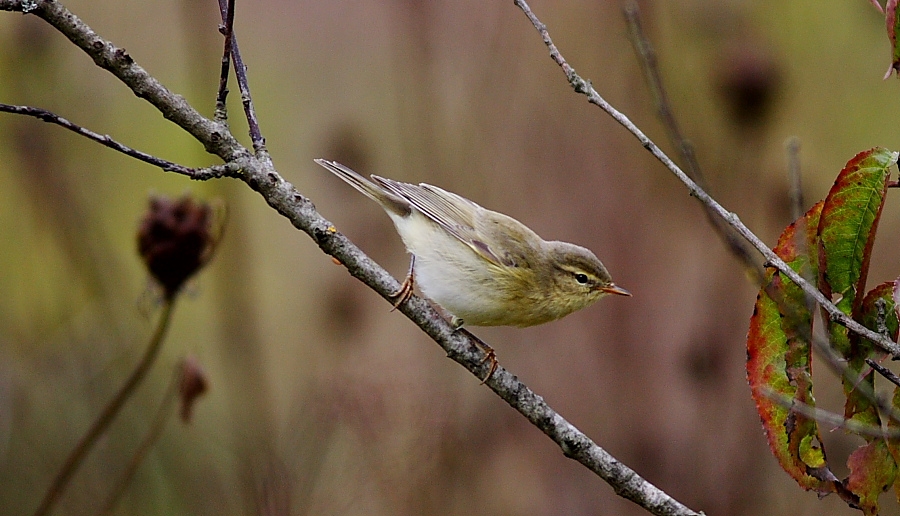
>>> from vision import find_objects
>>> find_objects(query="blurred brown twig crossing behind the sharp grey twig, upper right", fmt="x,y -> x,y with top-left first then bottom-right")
625,2 -> 765,285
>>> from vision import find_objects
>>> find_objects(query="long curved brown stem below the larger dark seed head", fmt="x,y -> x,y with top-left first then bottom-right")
34,298 -> 175,516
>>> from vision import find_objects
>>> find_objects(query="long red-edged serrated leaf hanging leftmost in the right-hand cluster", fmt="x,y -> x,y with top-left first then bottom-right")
747,202 -> 836,493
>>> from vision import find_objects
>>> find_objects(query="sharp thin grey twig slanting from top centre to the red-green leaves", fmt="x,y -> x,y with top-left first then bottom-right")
515,0 -> 900,359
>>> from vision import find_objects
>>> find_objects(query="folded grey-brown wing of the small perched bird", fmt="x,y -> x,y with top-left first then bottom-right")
372,176 -> 503,265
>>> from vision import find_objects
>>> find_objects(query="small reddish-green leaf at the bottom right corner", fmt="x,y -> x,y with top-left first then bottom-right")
844,439 -> 897,516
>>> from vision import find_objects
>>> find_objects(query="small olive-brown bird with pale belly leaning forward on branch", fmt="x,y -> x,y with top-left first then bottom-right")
315,159 -> 631,374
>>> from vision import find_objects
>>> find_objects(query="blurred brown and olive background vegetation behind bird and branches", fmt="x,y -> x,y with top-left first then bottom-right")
0,0 -> 900,515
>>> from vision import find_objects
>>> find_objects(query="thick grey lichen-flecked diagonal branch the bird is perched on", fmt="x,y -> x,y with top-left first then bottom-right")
0,0 -> 702,516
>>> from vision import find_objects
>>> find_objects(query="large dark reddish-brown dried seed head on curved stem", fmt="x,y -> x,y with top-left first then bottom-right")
138,196 -> 219,299
